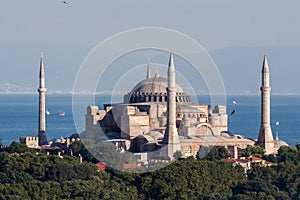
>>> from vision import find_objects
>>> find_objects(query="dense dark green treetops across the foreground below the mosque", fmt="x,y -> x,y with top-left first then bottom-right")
0,141 -> 300,199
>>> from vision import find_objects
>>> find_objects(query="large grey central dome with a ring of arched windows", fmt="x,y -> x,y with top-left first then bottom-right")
124,73 -> 191,103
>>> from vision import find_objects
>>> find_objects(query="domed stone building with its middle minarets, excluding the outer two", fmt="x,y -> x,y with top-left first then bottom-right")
84,53 -> 255,158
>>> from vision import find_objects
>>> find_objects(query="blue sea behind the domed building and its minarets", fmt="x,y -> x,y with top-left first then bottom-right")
0,94 -> 300,146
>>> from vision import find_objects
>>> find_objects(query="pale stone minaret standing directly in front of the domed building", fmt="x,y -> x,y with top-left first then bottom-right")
163,52 -> 181,159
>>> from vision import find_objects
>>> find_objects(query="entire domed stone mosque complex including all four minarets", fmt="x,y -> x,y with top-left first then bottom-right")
20,52 -> 287,160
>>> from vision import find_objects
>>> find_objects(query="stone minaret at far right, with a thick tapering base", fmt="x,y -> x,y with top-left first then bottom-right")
257,54 -> 274,154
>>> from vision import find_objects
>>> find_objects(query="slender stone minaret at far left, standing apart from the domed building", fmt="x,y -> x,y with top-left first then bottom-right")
38,55 -> 47,146
